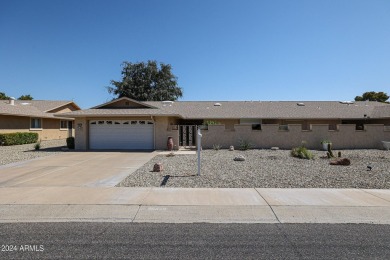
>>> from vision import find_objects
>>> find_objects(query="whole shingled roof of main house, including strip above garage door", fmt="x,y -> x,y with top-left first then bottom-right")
55,101 -> 390,119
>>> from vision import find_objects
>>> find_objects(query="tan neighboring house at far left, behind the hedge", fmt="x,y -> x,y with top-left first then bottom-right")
0,99 -> 80,140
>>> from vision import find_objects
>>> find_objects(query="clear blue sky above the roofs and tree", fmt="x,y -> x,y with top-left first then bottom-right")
0,0 -> 390,108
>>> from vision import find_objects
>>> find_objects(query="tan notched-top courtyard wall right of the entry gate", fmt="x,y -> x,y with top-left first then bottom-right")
202,124 -> 390,149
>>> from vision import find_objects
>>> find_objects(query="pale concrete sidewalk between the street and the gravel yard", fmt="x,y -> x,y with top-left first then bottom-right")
0,187 -> 390,224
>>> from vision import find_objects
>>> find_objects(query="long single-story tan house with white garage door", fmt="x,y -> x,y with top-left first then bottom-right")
56,98 -> 390,150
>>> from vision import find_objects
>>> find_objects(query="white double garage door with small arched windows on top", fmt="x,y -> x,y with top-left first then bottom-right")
89,120 -> 154,150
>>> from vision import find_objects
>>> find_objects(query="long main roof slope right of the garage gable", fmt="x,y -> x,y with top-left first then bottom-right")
145,101 -> 390,119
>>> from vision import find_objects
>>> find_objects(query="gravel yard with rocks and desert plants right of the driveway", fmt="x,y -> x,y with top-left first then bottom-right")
117,150 -> 390,189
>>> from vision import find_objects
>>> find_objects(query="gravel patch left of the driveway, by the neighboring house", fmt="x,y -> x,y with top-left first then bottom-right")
0,139 -> 66,165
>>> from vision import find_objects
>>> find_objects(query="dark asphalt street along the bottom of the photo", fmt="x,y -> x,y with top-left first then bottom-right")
0,223 -> 390,259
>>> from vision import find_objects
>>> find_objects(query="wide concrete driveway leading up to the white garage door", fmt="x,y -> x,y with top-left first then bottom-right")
0,151 -> 157,187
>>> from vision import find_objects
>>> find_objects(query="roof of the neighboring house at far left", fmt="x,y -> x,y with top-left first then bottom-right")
0,100 -> 78,118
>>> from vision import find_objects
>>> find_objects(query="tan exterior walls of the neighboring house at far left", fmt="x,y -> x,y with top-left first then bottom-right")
0,115 -> 72,140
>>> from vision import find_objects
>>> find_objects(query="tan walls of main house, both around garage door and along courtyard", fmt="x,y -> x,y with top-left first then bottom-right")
74,117 -> 390,150
